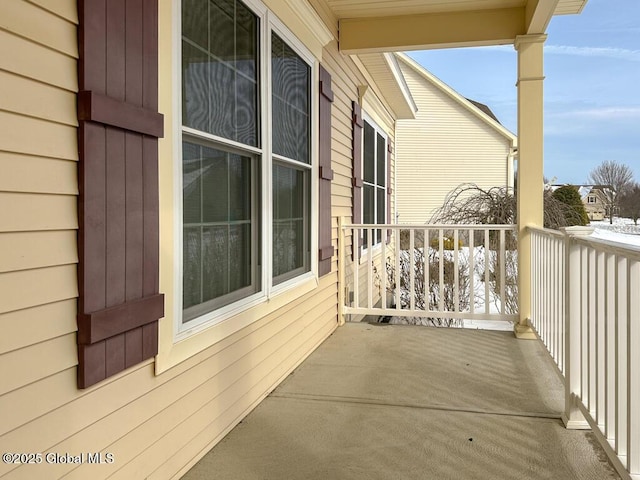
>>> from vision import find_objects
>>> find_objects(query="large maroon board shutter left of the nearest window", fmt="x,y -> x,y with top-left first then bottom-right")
78,0 -> 164,388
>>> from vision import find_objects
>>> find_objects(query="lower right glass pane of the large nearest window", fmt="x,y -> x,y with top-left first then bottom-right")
273,165 -> 310,284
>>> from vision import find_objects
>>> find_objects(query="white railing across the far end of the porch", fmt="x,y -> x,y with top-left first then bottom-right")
340,225 -> 517,321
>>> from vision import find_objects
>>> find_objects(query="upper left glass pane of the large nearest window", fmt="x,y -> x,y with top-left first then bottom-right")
182,0 -> 259,146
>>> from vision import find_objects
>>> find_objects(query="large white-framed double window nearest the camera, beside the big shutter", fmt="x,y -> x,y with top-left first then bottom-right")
178,0 -> 314,327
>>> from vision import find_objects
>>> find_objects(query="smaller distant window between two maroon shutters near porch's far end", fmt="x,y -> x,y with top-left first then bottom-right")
362,118 -> 388,248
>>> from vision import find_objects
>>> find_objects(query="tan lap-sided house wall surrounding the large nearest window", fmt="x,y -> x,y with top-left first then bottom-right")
0,0 -> 394,479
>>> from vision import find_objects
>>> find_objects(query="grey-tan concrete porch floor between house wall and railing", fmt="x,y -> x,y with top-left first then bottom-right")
183,323 -> 619,480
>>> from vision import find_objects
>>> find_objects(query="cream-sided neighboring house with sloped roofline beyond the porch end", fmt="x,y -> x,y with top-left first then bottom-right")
395,54 -> 517,223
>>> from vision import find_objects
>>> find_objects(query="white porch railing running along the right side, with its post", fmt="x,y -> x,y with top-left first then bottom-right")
530,227 -> 640,479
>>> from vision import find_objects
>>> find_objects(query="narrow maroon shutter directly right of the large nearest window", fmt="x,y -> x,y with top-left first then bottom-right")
318,65 -> 333,276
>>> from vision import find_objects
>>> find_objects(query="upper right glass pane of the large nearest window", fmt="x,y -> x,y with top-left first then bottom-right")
271,33 -> 311,163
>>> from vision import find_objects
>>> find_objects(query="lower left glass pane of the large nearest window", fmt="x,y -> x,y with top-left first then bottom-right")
183,142 -> 260,322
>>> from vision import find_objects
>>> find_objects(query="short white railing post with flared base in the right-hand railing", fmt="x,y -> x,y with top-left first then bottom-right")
562,227 -> 593,430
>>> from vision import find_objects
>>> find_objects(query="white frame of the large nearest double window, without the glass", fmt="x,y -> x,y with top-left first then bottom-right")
173,0 -> 319,342
